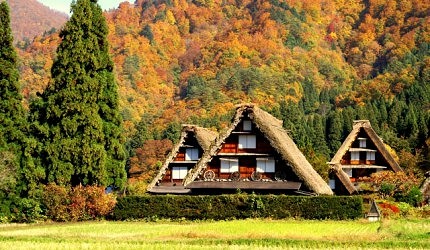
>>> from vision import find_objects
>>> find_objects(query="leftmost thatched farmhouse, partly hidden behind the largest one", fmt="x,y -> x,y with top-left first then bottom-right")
147,125 -> 218,194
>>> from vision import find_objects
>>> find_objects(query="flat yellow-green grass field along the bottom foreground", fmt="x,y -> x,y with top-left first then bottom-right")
0,219 -> 430,250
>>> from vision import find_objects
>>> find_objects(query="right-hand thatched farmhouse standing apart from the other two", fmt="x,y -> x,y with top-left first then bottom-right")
328,120 -> 403,194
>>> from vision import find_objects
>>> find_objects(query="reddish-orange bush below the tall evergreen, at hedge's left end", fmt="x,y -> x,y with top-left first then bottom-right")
42,184 -> 116,221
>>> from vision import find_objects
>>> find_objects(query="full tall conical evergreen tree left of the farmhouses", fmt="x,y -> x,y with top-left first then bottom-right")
32,0 -> 126,187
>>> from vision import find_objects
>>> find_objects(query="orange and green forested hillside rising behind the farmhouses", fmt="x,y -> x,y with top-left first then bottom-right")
15,0 -> 430,184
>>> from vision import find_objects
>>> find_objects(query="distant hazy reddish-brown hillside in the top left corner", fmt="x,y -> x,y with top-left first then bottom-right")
6,0 -> 68,42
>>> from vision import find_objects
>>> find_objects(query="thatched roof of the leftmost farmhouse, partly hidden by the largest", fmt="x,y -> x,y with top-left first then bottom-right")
147,124 -> 218,191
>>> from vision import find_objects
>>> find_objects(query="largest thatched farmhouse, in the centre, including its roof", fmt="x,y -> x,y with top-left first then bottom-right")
181,104 -> 333,195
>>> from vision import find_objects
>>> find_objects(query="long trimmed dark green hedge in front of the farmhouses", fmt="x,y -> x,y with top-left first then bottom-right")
113,194 -> 363,220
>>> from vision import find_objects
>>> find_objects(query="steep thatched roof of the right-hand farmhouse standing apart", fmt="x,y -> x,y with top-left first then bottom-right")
329,120 -> 403,193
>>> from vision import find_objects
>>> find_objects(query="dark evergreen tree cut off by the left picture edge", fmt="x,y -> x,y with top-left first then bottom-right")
0,1 -> 26,216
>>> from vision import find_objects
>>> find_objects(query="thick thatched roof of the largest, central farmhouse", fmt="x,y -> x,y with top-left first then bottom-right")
184,104 -> 333,195
